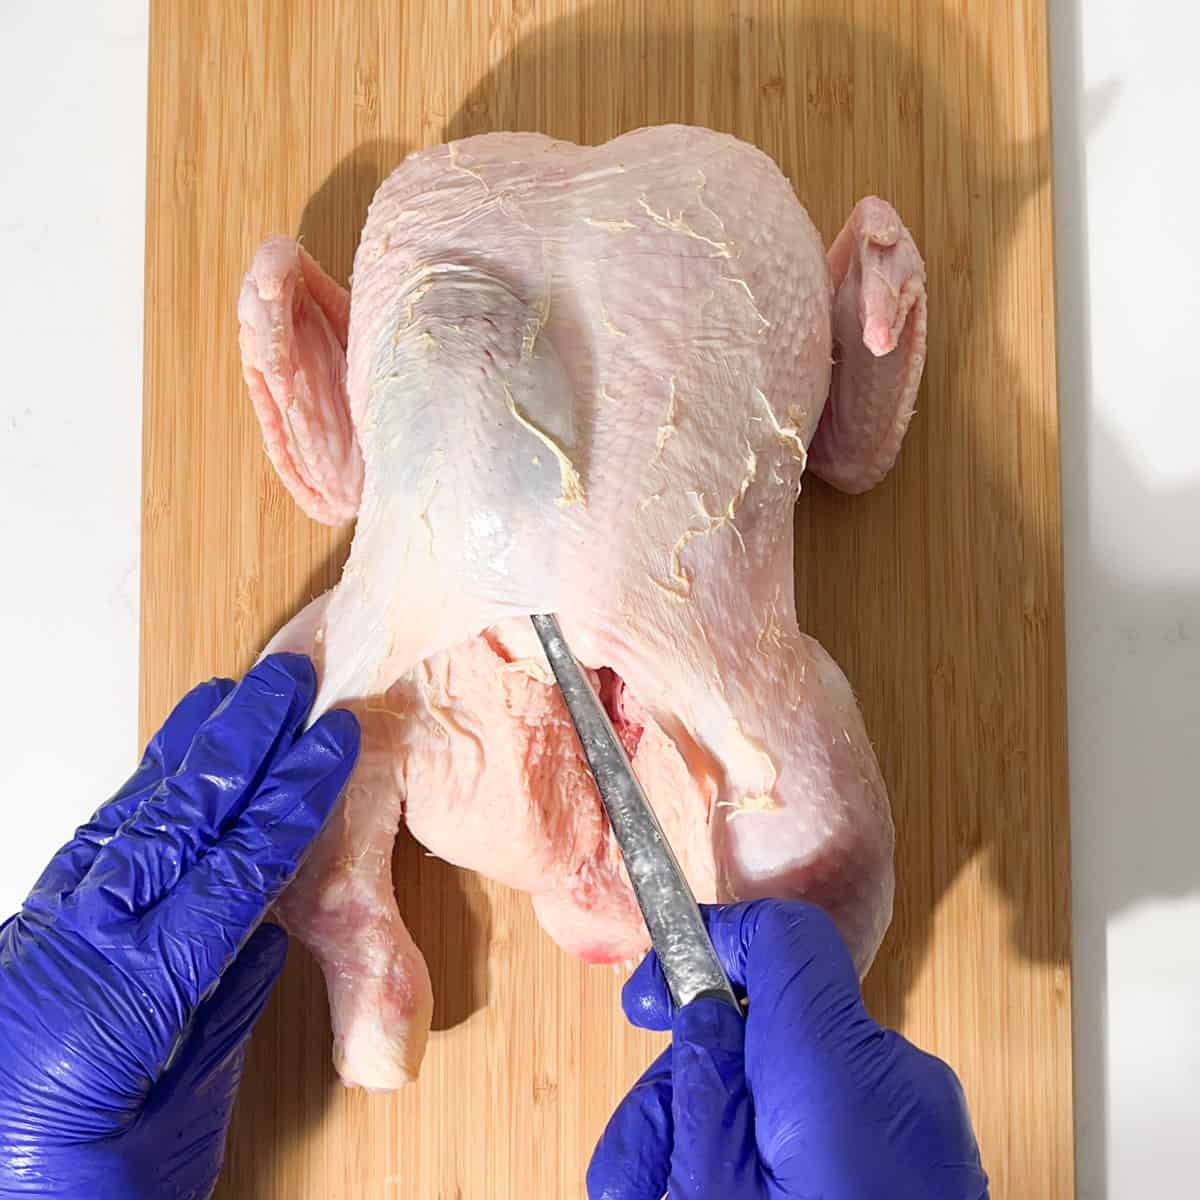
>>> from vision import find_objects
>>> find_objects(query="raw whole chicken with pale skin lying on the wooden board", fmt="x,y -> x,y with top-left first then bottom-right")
238,126 -> 925,1090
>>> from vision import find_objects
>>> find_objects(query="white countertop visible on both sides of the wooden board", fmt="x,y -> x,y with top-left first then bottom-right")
0,0 -> 1200,1200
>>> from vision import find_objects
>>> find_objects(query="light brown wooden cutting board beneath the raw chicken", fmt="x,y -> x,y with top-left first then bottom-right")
142,0 -> 1073,1200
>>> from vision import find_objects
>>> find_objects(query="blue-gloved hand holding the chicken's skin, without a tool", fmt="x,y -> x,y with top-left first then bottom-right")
0,655 -> 359,1200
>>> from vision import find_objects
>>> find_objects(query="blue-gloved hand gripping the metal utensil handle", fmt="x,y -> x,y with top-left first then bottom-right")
588,900 -> 988,1200
